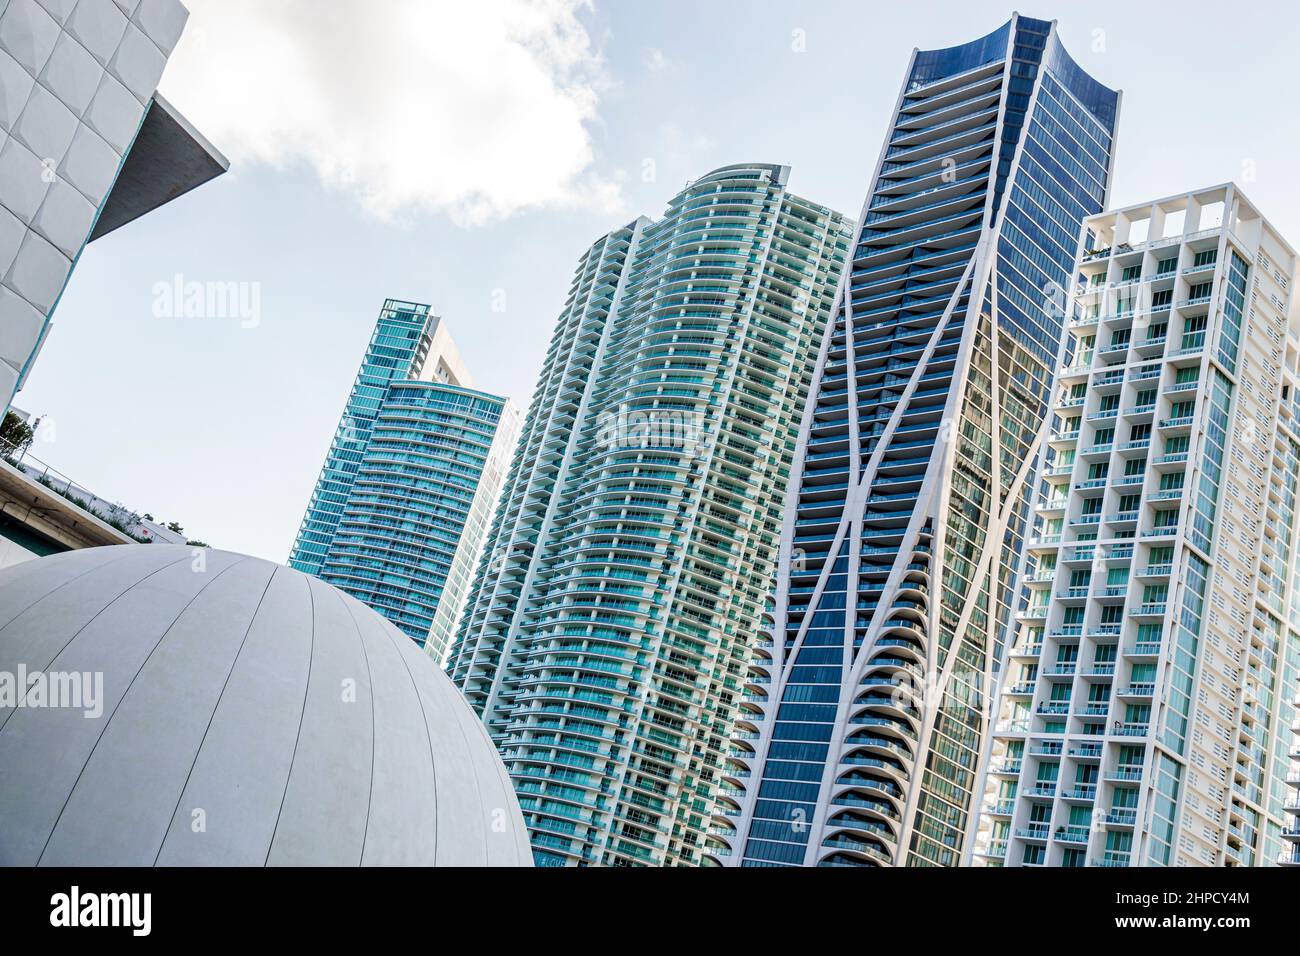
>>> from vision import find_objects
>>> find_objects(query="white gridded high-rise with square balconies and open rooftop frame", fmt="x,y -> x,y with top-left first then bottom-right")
974,185 -> 1300,866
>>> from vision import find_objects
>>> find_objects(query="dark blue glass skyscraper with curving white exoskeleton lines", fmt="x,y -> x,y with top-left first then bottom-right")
706,16 -> 1119,866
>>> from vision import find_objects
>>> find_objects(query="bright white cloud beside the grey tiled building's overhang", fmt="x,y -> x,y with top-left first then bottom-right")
163,0 -> 619,225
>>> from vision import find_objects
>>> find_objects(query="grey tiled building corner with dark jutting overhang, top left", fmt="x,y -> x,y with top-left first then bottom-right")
0,0 -> 229,414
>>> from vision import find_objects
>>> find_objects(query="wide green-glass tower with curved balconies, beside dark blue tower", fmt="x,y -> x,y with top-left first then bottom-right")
450,164 -> 849,865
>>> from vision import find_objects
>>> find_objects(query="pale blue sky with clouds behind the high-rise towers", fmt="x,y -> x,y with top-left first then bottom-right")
14,0 -> 1300,562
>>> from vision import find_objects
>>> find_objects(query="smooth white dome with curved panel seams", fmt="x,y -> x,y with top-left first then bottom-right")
0,545 -> 532,866
